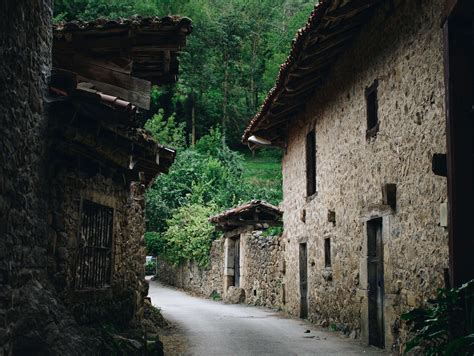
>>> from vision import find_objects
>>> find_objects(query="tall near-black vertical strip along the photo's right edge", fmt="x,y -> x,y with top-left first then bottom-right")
443,0 -> 474,287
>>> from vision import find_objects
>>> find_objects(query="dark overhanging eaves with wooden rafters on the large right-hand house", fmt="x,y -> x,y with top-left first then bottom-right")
242,0 -> 383,147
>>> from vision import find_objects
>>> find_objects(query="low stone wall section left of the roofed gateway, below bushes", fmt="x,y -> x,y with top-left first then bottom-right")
156,239 -> 224,298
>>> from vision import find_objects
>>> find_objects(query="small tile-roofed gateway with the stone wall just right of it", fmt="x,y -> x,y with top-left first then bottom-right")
209,200 -> 282,304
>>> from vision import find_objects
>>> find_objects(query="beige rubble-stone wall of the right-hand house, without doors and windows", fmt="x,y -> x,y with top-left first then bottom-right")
283,0 -> 448,351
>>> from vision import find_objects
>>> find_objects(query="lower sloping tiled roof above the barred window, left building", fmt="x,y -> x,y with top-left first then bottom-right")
50,70 -> 176,184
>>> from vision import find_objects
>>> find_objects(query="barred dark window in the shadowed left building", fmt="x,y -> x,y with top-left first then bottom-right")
75,200 -> 114,290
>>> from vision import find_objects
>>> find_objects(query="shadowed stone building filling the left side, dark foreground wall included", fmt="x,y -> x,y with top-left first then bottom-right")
0,6 -> 191,355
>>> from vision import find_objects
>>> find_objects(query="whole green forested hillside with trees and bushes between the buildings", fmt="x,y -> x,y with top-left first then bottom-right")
54,0 -> 315,264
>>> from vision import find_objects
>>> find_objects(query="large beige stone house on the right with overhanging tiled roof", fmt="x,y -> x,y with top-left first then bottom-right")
243,0 -> 473,351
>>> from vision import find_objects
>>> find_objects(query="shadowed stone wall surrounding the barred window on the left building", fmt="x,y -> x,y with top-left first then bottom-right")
48,167 -> 147,324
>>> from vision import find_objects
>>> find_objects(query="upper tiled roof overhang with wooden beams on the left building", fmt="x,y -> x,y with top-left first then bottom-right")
53,16 -> 192,109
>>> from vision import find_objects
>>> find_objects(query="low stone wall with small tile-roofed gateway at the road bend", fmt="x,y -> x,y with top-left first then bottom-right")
156,200 -> 285,308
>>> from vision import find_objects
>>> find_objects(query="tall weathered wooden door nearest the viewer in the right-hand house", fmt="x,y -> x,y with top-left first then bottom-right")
367,218 -> 385,348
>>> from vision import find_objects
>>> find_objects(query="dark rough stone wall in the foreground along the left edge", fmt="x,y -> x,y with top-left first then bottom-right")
0,0 -> 96,355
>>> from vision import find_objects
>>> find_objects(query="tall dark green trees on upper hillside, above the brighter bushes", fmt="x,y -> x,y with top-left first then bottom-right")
54,0 -> 316,149
